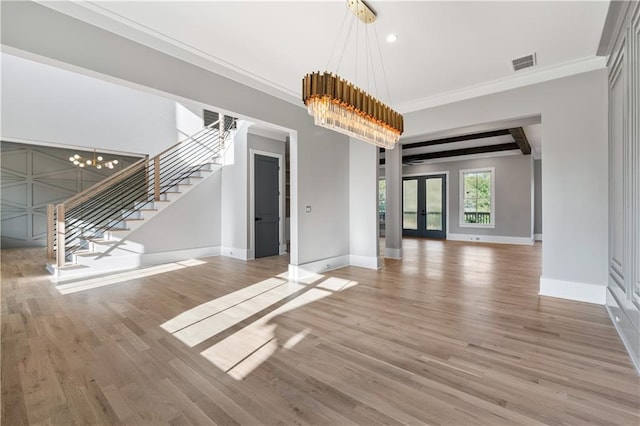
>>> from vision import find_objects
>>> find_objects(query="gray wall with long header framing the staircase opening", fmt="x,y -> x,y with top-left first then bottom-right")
1,2 -> 349,265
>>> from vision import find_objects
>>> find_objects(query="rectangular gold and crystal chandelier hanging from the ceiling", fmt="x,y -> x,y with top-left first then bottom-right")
302,0 -> 404,149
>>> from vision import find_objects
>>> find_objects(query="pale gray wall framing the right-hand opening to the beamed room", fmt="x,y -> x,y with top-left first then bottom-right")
405,69 -> 608,298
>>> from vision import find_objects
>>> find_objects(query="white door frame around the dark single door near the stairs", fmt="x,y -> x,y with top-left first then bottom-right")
247,148 -> 287,259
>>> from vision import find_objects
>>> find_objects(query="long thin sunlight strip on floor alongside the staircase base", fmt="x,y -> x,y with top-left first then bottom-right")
56,259 -> 206,294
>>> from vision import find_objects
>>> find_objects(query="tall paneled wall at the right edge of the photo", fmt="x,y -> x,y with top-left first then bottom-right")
607,2 -> 640,371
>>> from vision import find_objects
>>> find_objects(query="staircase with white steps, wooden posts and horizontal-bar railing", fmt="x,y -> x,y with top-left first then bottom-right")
47,116 -> 235,280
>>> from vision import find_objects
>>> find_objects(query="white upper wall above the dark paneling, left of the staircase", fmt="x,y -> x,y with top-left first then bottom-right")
1,51 -> 176,155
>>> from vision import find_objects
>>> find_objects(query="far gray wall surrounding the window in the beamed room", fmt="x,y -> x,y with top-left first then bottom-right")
402,155 -> 533,238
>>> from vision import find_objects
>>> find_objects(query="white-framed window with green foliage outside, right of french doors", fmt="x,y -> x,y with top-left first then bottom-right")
460,167 -> 495,228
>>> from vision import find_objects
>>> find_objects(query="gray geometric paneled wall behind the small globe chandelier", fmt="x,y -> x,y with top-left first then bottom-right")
0,141 -> 137,248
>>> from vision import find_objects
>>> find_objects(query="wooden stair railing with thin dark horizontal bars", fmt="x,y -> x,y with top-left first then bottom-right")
47,116 -> 235,267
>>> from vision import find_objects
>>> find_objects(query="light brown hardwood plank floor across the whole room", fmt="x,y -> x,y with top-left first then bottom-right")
1,239 -> 640,425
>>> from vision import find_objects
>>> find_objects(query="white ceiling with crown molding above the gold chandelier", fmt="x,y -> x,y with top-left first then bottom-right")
43,0 -> 609,155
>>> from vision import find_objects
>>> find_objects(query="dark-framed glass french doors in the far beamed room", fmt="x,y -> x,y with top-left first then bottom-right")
402,174 -> 447,238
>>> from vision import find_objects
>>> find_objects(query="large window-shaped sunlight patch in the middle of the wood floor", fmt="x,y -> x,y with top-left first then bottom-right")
161,272 -> 358,380
